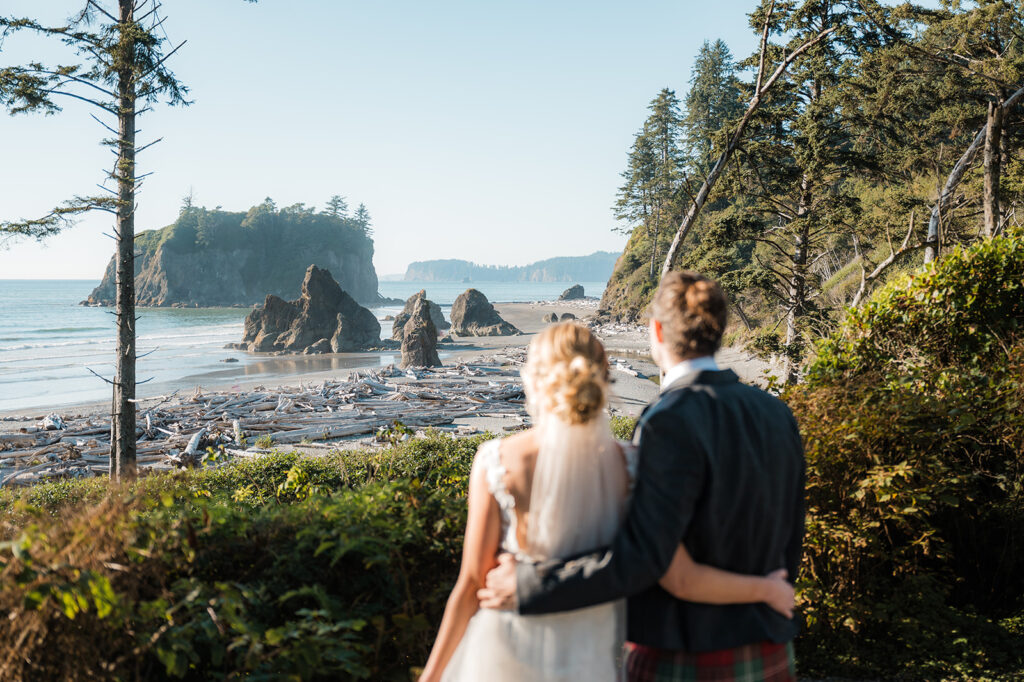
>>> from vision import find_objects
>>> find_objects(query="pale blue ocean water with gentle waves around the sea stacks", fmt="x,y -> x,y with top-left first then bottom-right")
0,280 -> 604,414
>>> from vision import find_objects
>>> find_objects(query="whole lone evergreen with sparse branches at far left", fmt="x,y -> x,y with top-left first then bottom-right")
0,0 -> 254,478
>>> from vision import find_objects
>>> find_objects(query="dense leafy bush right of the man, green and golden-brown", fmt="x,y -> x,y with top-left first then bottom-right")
784,235 -> 1024,679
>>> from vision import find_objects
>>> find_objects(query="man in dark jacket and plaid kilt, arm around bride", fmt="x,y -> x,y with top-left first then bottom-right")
479,272 -> 804,682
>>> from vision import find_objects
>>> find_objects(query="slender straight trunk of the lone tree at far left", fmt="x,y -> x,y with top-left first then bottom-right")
111,0 -> 136,479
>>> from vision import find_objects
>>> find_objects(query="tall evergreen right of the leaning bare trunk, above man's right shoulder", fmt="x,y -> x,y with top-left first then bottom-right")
741,0 -> 862,382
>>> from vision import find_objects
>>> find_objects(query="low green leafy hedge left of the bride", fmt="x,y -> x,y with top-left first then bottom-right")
0,434 -> 483,680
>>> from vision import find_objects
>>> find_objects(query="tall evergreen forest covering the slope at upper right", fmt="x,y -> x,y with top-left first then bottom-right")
601,0 -> 1024,381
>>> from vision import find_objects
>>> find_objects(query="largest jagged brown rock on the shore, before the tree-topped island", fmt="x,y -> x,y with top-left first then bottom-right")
236,265 -> 381,353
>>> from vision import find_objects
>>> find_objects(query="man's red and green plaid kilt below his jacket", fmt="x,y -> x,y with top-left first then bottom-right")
626,642 -> 797,682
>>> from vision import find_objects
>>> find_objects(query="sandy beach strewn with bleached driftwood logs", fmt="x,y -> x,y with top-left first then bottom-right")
0,299 -> 767,484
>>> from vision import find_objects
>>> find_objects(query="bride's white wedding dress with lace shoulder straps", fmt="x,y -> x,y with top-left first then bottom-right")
442,427 -> 637,682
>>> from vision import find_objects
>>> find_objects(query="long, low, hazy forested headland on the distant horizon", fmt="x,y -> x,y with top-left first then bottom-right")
406,251 -> 618,282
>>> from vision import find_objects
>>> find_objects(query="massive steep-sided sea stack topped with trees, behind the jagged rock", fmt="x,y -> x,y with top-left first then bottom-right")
84,205 -> 379,307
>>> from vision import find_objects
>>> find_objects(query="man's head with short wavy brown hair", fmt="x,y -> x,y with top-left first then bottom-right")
650,271 -> 728,370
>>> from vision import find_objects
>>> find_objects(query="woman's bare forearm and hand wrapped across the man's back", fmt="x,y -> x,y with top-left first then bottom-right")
658,545 -> 795,619
